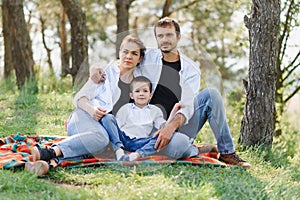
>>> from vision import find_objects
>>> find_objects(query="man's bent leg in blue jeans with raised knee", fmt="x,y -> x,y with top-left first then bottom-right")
179,88 -> 235,154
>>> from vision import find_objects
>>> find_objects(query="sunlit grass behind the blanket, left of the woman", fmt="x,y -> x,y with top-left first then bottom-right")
0,77 -> 73,135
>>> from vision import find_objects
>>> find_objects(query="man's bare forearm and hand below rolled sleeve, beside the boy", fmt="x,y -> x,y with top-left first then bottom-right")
153,113 -> 186,152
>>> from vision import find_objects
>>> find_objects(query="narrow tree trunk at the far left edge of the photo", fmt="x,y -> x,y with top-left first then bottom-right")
2,1 -> 14,79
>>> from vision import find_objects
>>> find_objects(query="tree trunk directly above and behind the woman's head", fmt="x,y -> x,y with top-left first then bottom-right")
116,0 -> 134,58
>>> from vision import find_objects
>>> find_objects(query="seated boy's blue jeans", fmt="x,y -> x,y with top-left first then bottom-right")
100,114 -> 157,157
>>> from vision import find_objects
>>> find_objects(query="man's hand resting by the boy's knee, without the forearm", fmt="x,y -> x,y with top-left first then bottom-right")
153,125 -> 176,152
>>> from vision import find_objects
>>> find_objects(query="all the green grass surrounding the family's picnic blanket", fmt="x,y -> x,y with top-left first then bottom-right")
0,79 -> 300,199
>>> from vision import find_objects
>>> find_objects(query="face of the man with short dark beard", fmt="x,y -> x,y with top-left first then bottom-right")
155,26 -> 180,53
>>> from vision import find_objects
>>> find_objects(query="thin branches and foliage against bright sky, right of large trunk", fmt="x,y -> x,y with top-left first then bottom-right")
276,0 -> 300,113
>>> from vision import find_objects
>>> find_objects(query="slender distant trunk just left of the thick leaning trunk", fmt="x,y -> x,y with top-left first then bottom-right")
59,7 -> 70,77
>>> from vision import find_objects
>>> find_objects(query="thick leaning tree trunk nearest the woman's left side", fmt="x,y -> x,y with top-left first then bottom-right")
61,0 -> 89,90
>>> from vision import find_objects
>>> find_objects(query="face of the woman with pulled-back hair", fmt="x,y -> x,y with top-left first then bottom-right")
119,42 -> 141,69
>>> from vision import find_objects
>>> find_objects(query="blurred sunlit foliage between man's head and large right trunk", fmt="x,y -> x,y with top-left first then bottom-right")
183,0 -> 248,80
